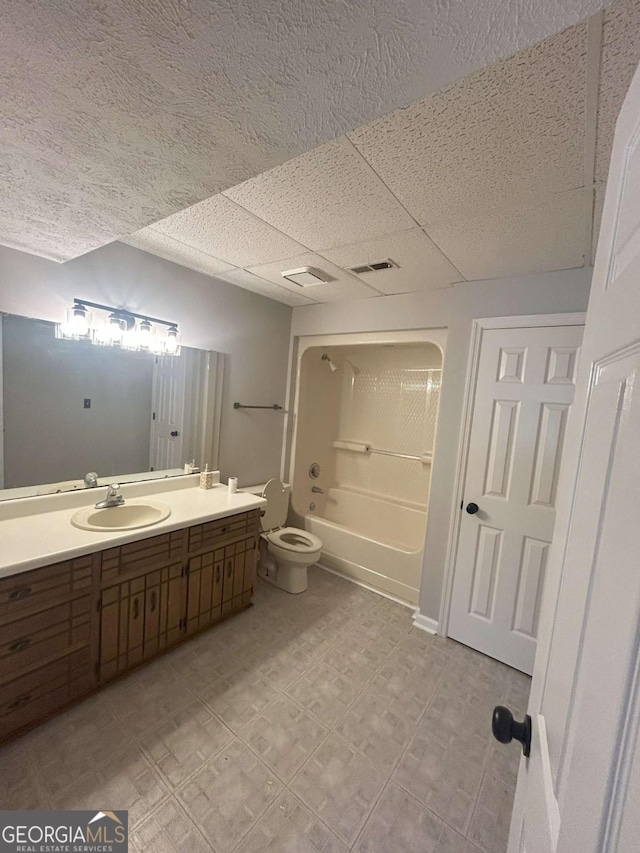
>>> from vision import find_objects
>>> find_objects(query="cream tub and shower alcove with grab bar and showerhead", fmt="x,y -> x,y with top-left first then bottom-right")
292,336 -> 442,603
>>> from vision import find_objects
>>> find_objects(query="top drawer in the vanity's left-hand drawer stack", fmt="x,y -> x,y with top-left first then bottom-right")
0,554 -> 93,625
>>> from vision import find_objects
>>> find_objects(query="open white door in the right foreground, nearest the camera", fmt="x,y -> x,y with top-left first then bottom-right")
505,55 -> 640,853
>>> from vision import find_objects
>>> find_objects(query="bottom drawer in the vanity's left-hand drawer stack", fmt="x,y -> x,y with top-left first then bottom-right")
0,647 -> 93,740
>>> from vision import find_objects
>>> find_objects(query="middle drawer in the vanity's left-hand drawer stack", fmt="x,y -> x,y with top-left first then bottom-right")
0,595 -> 91,683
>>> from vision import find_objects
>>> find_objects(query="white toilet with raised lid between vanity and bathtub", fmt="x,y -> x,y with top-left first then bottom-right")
258,478 -> 322,593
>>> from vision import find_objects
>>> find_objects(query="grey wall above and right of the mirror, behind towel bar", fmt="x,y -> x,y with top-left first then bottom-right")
0,243 -> 291,485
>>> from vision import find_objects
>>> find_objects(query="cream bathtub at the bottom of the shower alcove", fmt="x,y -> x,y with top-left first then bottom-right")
303,488 -> 427,604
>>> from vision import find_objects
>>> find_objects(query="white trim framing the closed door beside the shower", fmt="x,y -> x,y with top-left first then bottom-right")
438,311 -> 587,637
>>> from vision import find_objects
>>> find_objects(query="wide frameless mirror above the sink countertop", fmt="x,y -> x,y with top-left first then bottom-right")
0,314 -> 223,500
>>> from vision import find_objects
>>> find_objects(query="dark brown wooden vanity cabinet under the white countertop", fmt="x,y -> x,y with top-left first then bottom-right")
0,510 -> 260,741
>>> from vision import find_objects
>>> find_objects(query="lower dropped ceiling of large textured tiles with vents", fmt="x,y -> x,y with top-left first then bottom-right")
121,0 -> 640,305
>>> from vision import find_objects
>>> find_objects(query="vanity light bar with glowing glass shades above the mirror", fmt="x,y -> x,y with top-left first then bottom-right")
56,299 -> 180,355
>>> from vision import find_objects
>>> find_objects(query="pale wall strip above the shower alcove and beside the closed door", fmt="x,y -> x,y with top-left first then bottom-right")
291,269 -> 591,619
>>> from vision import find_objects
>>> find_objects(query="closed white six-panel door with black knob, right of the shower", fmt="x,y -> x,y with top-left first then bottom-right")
449,326 -> 583,674
